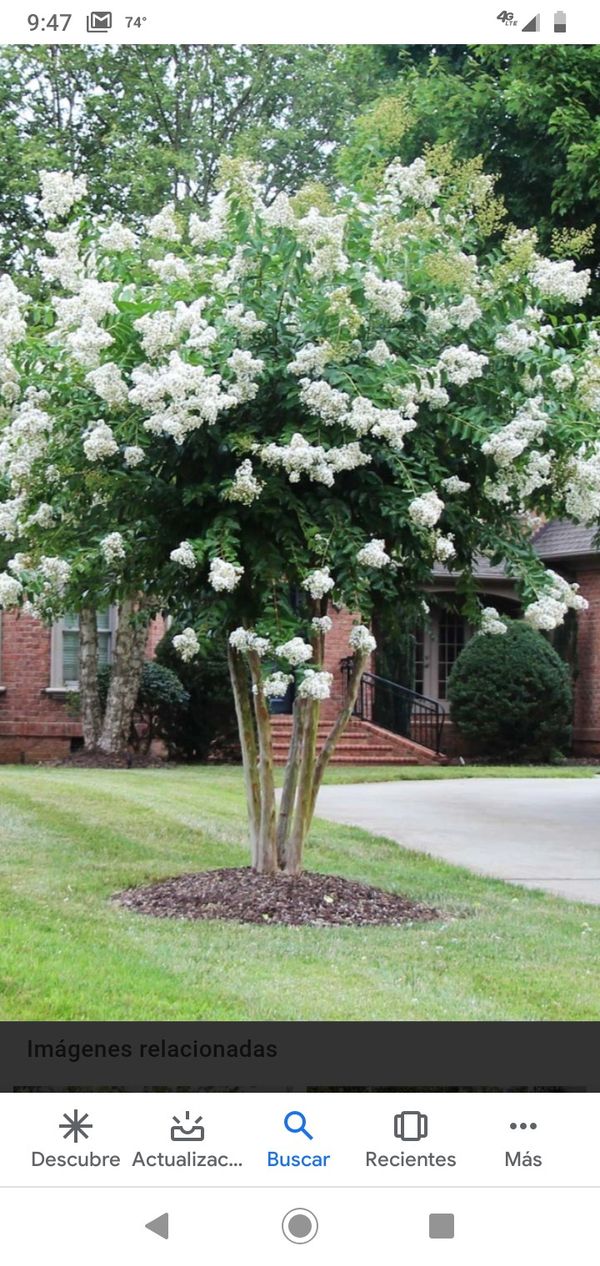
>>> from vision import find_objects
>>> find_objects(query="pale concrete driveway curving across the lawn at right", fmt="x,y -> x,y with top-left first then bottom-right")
316,777 -> 600,905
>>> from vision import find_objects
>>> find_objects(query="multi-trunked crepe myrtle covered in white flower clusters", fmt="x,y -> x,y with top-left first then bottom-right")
0,148 -> 600,874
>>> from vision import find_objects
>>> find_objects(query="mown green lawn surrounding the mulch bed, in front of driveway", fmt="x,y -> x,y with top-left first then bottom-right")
0,767 -> 600,1022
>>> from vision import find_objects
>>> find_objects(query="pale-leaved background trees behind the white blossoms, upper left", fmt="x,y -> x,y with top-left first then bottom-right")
0,44 -> 389,267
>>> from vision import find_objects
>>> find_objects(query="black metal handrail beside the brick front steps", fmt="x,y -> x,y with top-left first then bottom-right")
342,656 -> 446,752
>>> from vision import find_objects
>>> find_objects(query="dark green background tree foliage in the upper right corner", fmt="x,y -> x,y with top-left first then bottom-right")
339,44 -> 600,287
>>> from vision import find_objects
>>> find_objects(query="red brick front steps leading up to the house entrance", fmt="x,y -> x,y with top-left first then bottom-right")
271,715 -> 443,766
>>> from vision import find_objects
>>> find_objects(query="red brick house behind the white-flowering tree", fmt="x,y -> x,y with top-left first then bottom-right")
0,523 -> 600,763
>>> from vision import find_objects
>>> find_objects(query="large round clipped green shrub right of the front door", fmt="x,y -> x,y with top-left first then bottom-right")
448,620 -> 573,761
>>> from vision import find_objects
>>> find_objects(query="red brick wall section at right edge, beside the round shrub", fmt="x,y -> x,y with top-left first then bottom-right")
573,566 -> 600,756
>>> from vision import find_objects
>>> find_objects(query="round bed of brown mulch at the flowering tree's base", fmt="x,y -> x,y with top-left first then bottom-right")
114,867 -> 442,927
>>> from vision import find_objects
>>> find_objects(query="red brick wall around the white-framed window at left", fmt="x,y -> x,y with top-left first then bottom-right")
0,611 -> 165,763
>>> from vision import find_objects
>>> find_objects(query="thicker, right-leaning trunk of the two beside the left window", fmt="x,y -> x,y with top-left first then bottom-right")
97,598 -> 148,755
